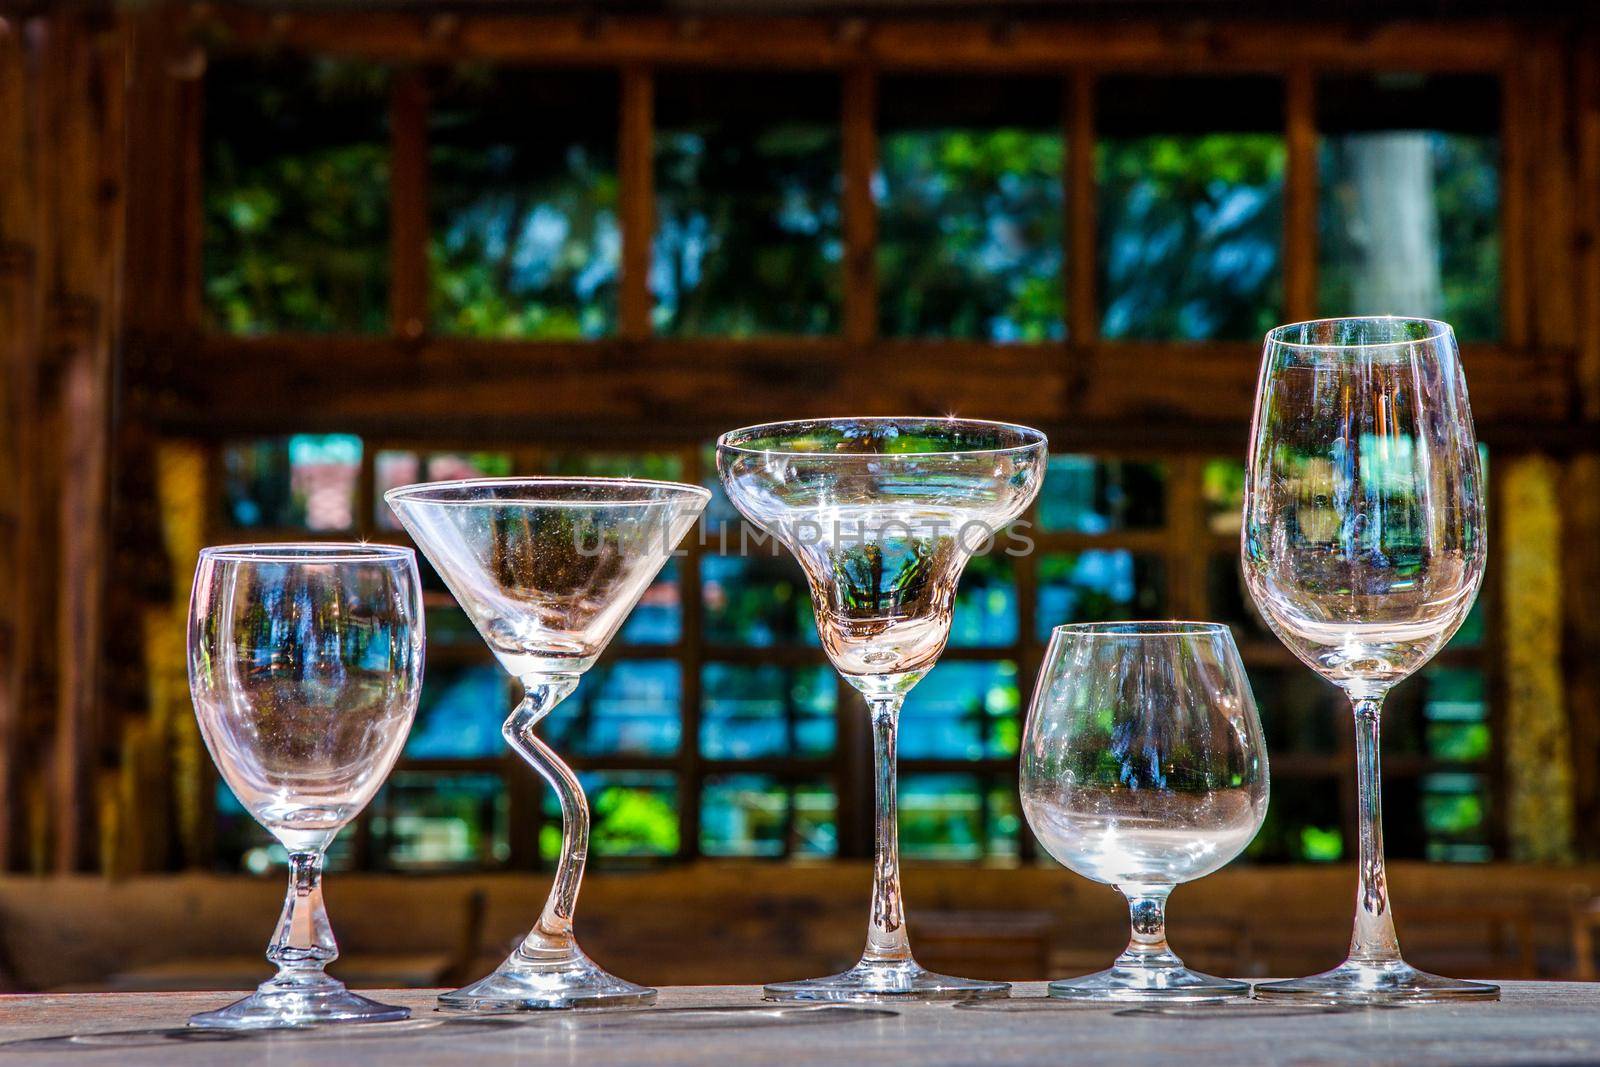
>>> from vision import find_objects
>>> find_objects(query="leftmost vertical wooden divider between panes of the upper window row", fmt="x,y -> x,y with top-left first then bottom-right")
389,67 -> 429,341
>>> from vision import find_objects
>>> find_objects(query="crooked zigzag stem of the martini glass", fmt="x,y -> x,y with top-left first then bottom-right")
501,675 -> 589,961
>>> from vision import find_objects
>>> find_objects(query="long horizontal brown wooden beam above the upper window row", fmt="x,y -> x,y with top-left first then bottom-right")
192,5 -> 1514,72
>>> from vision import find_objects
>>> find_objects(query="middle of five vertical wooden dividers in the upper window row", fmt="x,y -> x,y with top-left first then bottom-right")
842,66 -> 878,344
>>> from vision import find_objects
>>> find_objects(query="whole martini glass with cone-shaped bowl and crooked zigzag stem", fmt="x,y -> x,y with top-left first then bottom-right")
384,478 -> 710,1013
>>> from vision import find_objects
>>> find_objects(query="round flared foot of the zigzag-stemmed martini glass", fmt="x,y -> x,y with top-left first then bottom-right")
438,947 -> 656,1014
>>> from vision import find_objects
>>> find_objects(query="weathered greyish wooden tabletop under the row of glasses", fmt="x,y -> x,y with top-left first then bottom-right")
0,982 -> 1600,1067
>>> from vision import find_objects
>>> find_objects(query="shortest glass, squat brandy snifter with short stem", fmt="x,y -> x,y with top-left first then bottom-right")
1019,622 -> 1267,1001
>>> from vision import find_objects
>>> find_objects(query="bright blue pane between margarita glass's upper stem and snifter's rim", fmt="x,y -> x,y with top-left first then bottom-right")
899,659 -> 1022,760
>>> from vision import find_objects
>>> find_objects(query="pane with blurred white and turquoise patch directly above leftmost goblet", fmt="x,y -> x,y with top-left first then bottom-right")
222,434 -> 362,531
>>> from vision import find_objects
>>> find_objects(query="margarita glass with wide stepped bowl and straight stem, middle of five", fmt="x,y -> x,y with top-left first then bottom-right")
717,418 -> 1046,1000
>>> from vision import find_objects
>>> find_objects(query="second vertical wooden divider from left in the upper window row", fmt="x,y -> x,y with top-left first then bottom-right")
618,64 -> 656,341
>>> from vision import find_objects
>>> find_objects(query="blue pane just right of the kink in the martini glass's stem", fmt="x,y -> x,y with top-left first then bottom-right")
544,659 -> 683,757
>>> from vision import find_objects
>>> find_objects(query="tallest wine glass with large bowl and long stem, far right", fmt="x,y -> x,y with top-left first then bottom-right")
1242,318 -> 1499,1001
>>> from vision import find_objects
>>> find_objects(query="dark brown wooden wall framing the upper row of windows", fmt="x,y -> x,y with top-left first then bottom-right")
0,5 -> 1600,870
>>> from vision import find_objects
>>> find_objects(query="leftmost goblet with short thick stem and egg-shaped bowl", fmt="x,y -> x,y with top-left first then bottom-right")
189,542 -> 422,1029
